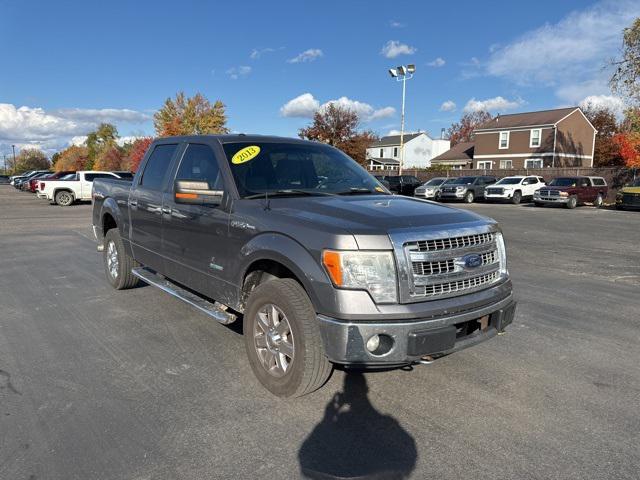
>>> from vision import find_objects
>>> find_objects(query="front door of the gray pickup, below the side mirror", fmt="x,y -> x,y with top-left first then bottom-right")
162,143 -> 229,299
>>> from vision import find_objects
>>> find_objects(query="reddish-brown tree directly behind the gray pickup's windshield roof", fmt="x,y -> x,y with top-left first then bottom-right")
298,103 -> 378,166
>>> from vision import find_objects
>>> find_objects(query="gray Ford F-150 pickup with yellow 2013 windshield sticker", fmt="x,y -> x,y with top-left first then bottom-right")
92,135 -> 516,397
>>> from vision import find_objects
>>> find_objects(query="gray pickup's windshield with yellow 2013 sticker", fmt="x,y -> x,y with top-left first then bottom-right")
223,142 -> 387,198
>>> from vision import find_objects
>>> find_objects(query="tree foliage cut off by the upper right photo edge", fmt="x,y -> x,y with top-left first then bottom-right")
610,18 -> 640,104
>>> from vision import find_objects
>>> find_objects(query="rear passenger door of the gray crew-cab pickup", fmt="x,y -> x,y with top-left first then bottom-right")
129,142 -> 180,273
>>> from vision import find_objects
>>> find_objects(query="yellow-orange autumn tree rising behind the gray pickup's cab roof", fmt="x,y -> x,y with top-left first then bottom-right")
153,92 -> 229,137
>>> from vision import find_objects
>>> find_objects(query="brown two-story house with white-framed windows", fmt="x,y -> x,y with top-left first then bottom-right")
473,107 -> 596,170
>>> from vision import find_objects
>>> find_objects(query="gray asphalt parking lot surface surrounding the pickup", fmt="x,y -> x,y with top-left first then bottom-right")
0,185 -> 640,480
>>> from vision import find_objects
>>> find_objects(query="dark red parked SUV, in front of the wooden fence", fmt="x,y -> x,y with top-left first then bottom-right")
533,177 -> 609,208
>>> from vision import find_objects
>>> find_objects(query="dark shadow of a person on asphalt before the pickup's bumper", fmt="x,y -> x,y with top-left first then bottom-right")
298,372 -> 417,480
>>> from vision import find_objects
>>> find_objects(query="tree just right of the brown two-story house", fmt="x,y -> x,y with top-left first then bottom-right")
582,103 -> 624,167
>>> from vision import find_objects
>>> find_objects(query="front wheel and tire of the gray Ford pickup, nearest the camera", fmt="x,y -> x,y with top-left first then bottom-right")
243,278 -> 333,397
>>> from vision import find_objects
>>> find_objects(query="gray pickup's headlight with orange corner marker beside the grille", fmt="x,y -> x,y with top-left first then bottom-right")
322,250 -> 398,303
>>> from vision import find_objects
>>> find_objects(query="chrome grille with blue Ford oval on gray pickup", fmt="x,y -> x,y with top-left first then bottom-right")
403,232 -> 500,300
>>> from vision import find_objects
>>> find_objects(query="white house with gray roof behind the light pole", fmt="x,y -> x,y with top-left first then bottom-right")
367,132 -> 450,170
